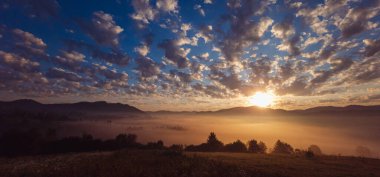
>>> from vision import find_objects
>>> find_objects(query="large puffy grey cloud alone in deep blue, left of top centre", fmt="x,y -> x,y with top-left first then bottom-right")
81,11 -> 124,46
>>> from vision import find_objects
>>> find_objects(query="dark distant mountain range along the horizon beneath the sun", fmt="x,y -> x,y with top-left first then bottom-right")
0,99 -> 380,115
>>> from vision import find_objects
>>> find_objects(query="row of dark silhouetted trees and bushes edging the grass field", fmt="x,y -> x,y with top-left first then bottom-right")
0,129 -> 322,156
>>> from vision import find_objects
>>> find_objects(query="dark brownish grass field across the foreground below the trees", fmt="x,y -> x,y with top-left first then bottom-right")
0,150 -> 380,177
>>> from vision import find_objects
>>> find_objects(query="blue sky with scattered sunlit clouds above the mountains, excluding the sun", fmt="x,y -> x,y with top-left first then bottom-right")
0,0 -> 380,111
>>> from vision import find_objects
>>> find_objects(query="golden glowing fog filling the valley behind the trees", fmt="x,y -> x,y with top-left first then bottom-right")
58,114 -> 380,157
